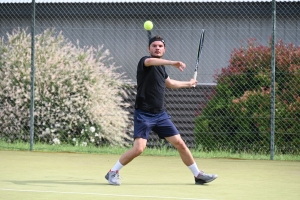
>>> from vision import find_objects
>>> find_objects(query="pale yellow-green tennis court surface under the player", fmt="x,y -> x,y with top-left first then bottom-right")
0,151 -> 300,200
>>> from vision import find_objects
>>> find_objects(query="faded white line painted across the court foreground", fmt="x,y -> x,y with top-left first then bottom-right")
0,188 -> 209,200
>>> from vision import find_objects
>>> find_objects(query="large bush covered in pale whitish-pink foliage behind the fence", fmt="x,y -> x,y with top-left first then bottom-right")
0,29 -> 129,146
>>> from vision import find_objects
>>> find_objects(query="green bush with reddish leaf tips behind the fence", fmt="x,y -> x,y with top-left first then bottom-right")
194,39 -> 300,153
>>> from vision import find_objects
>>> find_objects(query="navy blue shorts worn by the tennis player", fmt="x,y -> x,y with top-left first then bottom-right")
133,109 -> 179,140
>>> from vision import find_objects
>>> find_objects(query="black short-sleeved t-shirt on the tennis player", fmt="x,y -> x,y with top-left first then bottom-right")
135,56 -> 168,113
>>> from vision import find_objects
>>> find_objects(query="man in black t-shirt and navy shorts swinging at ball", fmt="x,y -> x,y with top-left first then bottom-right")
105,36 -> 218,185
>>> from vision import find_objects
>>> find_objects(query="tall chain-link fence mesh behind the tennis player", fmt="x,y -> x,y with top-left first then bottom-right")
0,0 -> 300,154
